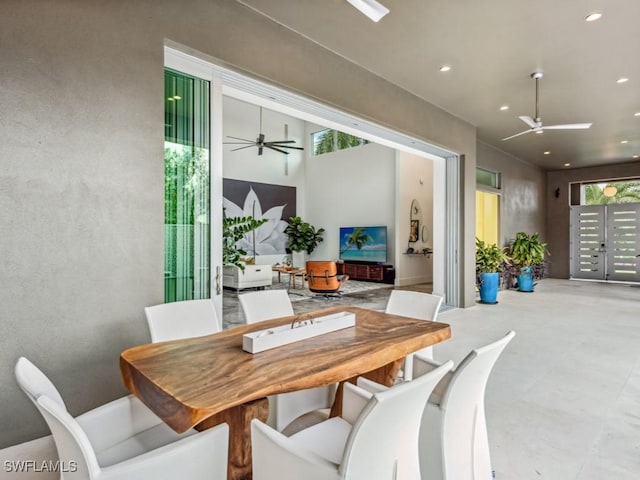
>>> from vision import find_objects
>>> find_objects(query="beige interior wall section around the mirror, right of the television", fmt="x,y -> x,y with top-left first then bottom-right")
395,151 -> 434,286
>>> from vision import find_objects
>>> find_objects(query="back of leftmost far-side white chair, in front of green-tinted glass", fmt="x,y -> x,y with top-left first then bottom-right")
144,298 -> 221,343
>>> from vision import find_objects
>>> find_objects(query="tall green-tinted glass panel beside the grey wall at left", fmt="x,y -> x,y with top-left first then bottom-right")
164,69 -> 210,302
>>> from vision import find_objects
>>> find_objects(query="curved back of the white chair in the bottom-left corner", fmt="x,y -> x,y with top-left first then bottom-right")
15,357 -> 100,480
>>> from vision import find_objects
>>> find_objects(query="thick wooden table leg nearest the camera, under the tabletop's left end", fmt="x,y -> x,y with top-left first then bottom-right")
196,398 -> 269,480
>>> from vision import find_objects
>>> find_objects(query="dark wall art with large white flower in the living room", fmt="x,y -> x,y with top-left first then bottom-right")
222,178 -> 296,256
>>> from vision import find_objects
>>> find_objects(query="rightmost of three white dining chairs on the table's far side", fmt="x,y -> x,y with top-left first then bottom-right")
385,290 -> 443,381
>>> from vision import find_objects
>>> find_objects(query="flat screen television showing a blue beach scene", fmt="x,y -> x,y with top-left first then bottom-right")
340,226 -> 387,263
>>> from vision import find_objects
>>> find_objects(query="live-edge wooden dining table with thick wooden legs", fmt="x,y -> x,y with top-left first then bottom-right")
120,305 -> 451,480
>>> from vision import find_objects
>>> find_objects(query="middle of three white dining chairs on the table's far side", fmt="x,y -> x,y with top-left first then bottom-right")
238,290 -> 337,431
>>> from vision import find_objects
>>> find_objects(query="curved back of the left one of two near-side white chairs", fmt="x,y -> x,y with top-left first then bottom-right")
339,361 -> 453,479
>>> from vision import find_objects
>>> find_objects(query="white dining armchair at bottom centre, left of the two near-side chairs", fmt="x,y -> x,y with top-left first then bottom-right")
251,362 -> 453,480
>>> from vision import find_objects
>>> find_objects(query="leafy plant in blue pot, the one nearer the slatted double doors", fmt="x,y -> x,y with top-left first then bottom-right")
509,232 -> 548,292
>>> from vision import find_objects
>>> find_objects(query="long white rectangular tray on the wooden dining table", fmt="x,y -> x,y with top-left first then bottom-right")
242,312 -> 356,353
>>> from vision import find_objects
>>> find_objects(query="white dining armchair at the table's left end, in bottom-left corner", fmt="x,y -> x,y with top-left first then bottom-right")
15,357 -> 229,480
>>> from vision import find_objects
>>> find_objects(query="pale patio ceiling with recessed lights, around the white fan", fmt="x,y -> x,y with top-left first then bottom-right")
239,0 -> 640,170
